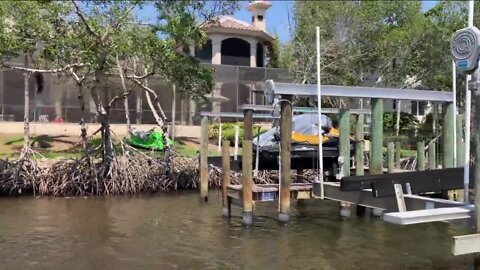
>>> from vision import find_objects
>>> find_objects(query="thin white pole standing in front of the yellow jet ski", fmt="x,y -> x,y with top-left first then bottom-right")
317,26 -> 325,200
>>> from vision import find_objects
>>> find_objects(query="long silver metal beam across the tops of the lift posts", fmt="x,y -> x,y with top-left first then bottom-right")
273,83 -> 453,102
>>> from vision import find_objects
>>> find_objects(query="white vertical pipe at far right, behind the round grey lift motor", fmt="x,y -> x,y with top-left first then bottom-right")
463,0 -> 474,203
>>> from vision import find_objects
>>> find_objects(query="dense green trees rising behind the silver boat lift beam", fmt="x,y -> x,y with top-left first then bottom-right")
282,1 -> 468,100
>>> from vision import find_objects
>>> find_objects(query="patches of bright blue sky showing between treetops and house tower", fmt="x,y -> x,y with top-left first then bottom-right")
137,0 -> 437,43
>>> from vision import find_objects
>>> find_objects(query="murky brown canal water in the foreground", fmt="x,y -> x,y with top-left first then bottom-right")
0,192 -> 473,270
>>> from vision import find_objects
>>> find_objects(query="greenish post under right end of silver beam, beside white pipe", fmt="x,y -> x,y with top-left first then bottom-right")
442,102 -> 455,169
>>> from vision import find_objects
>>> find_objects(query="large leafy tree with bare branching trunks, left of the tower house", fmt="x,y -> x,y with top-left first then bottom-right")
36,0 -> 240,176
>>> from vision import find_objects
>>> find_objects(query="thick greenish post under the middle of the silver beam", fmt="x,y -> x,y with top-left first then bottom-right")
370,98 -> 383,174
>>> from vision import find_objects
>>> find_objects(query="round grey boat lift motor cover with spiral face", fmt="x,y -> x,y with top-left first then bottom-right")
451,26 -> 480,74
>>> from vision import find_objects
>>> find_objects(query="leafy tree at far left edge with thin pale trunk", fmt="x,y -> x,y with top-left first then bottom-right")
0,1 -> 78,157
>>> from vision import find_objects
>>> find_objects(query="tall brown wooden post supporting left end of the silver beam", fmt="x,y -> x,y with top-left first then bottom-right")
278,95 -> 292,222
